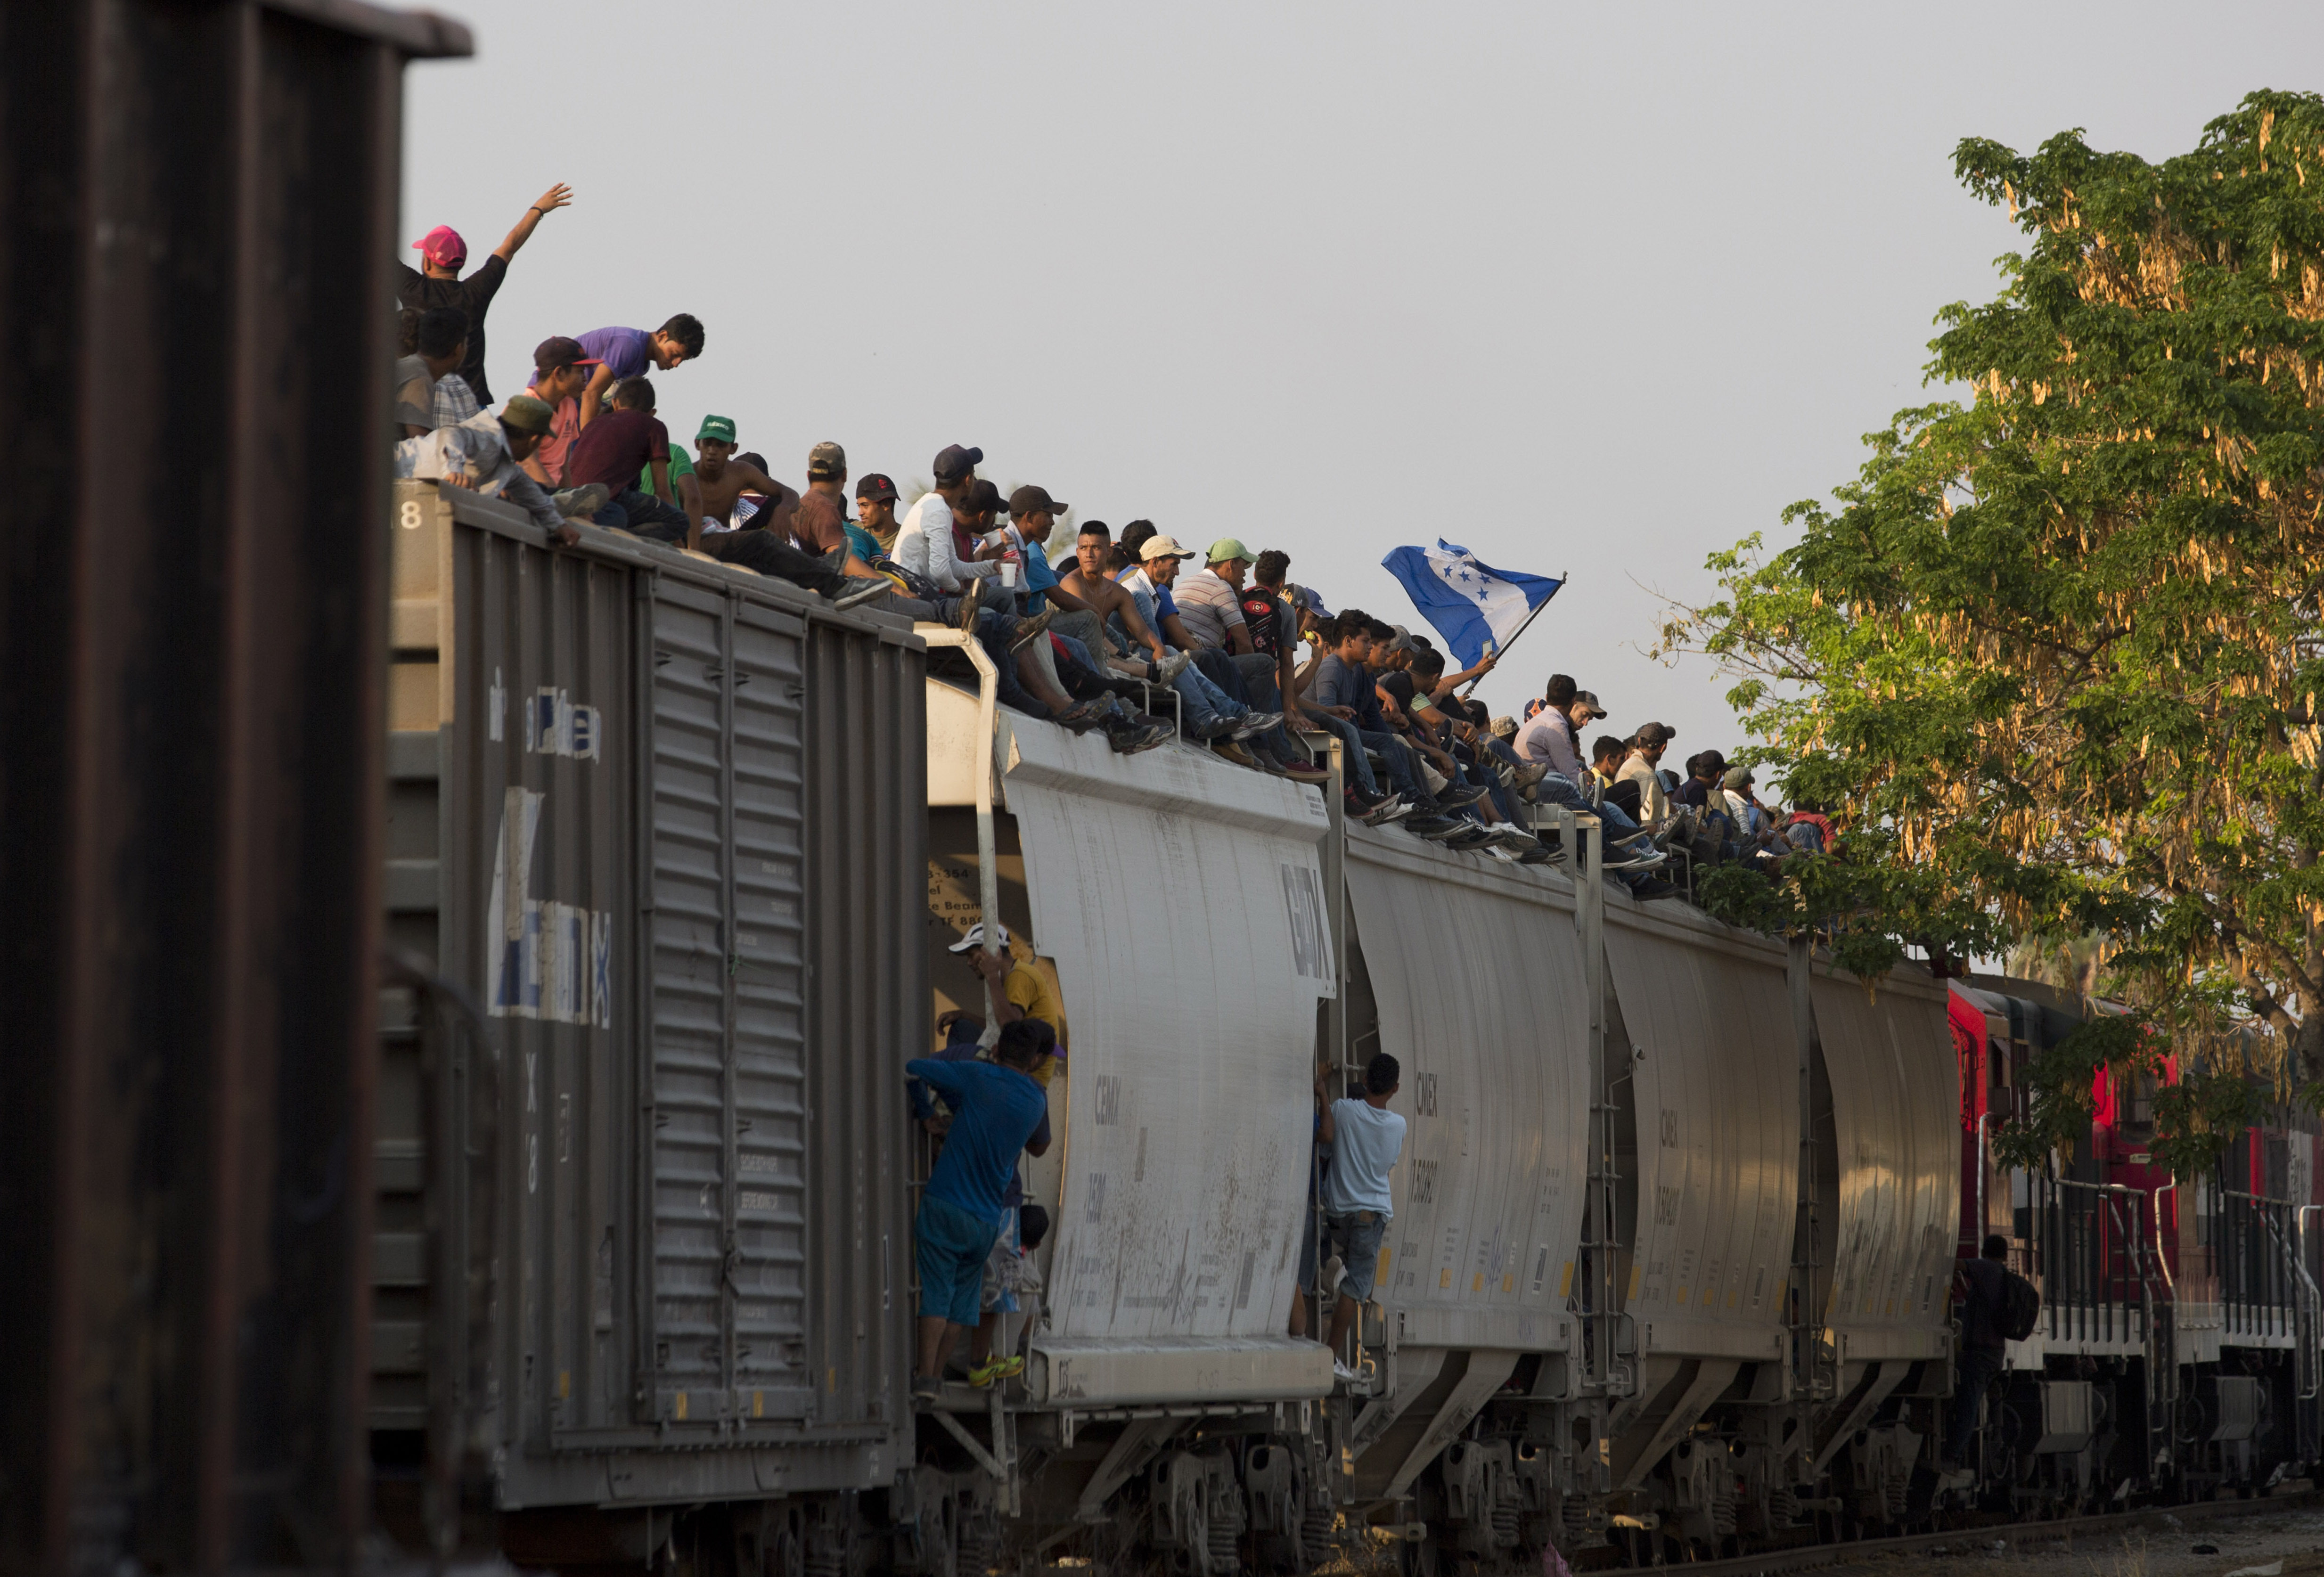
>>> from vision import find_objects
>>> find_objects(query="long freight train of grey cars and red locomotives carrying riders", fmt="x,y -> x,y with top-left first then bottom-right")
369,485 -> 2324,1577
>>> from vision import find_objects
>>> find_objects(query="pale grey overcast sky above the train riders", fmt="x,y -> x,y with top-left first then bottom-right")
404,0 -> 2324,757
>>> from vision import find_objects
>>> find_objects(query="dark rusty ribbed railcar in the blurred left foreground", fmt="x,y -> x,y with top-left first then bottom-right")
0,0 -> 467,1572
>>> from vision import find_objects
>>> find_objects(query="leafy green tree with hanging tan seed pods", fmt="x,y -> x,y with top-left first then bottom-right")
1664,93 -> 2324,1170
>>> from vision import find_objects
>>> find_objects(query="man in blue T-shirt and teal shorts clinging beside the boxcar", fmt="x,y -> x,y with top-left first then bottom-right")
904,1020 -> 1048,1400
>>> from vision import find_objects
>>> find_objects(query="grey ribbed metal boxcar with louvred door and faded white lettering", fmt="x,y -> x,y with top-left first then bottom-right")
374,485 -> 927,1505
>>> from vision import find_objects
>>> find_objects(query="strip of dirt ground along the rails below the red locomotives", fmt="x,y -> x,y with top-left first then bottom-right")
1815,1505 -> 2324,1577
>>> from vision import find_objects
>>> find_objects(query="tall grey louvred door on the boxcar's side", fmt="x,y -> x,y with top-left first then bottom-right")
653,585 -> 809,1419
